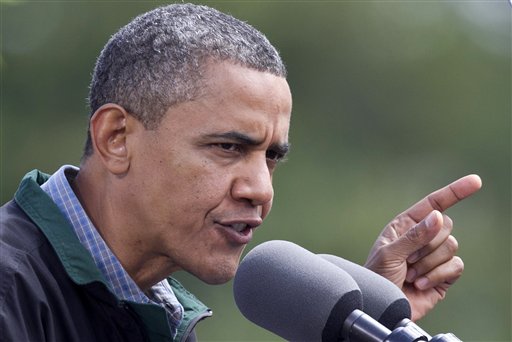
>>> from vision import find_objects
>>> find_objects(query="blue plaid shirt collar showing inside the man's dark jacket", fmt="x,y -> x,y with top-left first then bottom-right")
41,165 -> 183,336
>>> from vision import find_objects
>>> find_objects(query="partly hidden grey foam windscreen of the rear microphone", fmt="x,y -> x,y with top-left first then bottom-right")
319,254 -> 411,330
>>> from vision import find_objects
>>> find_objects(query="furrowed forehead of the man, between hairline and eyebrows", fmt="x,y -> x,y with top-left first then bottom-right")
162,62 -> 292,142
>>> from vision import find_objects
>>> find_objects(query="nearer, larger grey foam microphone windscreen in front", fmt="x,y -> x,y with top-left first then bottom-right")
233,241 -> 362,341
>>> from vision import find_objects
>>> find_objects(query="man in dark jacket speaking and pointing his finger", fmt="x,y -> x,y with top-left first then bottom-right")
0,4 -> 481,341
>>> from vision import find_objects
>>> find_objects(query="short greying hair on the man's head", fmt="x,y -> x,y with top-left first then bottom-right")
84,4 -> 286,156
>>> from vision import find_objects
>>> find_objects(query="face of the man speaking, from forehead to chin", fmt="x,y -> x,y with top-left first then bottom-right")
130,63 -> 291,284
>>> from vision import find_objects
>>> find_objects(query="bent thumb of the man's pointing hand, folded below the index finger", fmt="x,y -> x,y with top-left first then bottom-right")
392,210 -> 443,259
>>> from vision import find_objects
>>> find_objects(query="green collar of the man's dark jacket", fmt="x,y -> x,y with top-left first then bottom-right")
14,170 -> 212,341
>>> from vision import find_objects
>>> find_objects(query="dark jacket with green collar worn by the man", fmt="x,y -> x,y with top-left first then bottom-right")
0,170 -> 212,341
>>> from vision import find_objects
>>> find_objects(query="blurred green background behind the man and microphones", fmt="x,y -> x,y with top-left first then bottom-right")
0,0 -> 512,341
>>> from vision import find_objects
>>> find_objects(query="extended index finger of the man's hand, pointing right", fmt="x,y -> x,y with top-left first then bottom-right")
403,175 -> 482,222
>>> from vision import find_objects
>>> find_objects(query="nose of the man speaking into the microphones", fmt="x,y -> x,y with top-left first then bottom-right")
231,158 -> 274,206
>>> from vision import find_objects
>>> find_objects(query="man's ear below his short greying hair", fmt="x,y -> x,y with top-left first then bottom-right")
90,103 -> 132,175
